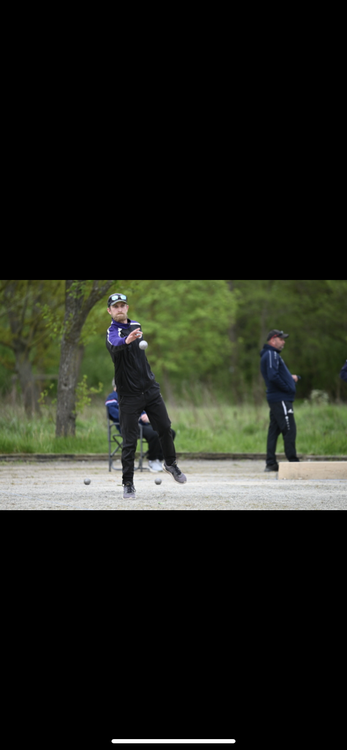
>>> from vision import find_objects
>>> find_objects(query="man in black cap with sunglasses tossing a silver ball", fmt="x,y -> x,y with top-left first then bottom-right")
106,294 -> 187,498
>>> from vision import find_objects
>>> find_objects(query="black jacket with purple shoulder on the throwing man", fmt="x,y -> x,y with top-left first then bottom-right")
106,318 -> 159,398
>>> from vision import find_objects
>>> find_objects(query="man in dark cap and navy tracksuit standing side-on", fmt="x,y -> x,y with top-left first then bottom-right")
260,328 -> 299,471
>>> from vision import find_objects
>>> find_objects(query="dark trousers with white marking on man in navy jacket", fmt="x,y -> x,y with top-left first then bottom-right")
266,401 -> 299,466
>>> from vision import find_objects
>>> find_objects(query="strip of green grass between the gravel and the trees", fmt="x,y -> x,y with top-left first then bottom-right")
0,400 -> 347,455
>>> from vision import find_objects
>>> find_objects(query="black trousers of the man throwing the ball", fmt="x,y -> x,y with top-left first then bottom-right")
119,385 -> 176,484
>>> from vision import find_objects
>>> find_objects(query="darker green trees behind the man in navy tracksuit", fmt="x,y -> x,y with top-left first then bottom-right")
230,280 -> 347,400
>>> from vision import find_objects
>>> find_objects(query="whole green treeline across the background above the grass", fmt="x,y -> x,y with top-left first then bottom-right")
0,280 -> 347,413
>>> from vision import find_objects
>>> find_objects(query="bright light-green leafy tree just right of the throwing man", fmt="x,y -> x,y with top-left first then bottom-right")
115,280 -> 236,389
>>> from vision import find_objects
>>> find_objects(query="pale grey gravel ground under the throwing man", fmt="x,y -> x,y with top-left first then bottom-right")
0,459 -> 347,510
